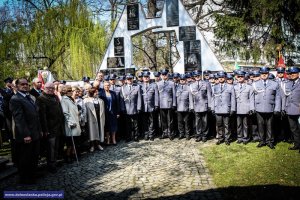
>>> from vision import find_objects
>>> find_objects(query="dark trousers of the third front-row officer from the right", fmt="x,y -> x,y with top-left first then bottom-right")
236,114 -> 250,142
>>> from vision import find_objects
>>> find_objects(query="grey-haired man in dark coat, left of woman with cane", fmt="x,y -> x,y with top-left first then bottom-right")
36,83 -> 64,173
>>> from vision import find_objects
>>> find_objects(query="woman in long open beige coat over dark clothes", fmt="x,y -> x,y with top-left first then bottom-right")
83,88 -> 105,152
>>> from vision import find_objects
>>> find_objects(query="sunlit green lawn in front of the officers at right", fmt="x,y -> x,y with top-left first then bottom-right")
200,143 -> 300,187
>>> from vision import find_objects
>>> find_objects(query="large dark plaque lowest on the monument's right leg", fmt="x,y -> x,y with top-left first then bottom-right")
184,40 -> 201,72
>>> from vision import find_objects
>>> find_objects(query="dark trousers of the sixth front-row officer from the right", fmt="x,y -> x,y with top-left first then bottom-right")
177,112 -> 191,137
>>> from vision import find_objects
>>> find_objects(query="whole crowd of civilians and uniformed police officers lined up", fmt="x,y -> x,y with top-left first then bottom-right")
0,67 -> 300,183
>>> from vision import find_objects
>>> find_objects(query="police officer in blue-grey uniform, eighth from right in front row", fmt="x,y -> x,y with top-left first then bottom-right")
141,71 -> 159,141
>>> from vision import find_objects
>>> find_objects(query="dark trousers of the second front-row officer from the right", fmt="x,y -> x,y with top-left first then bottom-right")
256,113 -> 274,144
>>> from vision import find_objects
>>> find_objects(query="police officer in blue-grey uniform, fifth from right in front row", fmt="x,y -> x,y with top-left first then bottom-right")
190,71 -> 212,142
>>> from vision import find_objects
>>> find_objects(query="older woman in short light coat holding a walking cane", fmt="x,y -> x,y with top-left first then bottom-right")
60,85 -> 81,163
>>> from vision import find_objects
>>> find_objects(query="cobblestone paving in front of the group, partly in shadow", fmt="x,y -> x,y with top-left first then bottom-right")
0,139 -> 221,199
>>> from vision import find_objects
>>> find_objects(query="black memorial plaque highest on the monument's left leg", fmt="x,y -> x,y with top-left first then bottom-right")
127,4 -> 140,31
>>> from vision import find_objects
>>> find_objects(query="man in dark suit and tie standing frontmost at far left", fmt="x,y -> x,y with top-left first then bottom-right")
9,78 -> 41,184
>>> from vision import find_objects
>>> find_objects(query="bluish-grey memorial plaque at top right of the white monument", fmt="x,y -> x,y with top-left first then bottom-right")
166,0 -> 179,27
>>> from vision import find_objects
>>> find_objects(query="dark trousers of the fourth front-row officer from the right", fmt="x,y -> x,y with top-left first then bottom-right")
216,114 -> 231,141
